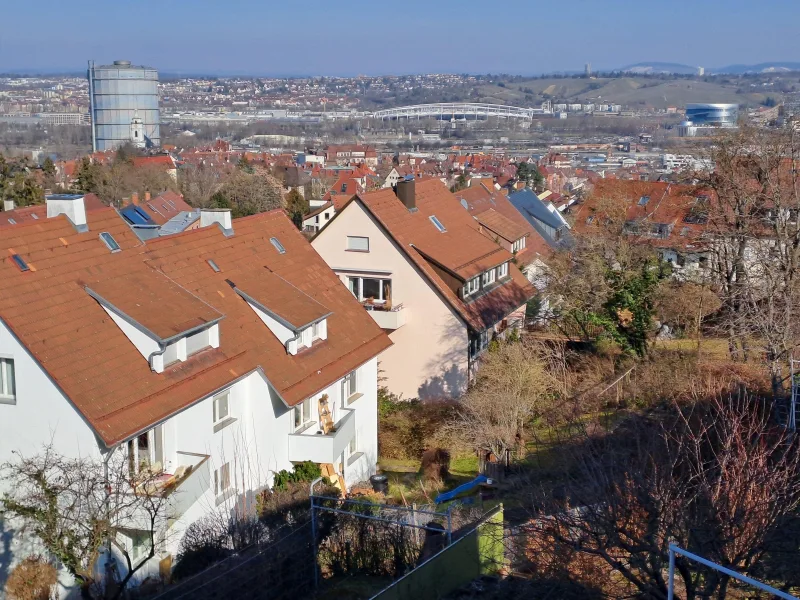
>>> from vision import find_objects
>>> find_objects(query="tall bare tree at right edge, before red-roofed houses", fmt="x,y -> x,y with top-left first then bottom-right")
705,127 -> 800,395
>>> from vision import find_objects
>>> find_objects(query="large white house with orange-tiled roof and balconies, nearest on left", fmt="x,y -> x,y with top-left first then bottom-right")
0,195 -> 391,591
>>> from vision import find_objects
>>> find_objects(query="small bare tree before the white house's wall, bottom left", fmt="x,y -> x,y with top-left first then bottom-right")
0,446 -> 172,599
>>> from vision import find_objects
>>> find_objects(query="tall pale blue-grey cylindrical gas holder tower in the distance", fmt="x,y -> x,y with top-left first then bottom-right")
88,60 -> 161,151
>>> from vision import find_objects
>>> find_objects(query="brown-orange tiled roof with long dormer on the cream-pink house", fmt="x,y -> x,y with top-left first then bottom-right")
334,179 -> 536,332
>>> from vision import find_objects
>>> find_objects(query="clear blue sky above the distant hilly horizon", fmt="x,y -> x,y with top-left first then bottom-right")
0,0 -> 800,75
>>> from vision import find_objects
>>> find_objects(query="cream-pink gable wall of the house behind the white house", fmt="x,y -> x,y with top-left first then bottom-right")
312,202 -> 469,399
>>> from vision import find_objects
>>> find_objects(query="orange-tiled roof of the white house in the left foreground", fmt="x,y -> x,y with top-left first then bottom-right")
0,208 -> 391,446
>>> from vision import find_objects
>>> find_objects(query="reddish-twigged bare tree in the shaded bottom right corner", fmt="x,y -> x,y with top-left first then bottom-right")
521,395 -> 800,600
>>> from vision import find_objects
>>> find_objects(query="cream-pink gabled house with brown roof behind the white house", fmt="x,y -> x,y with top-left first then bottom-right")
312,179 -> 535,398
